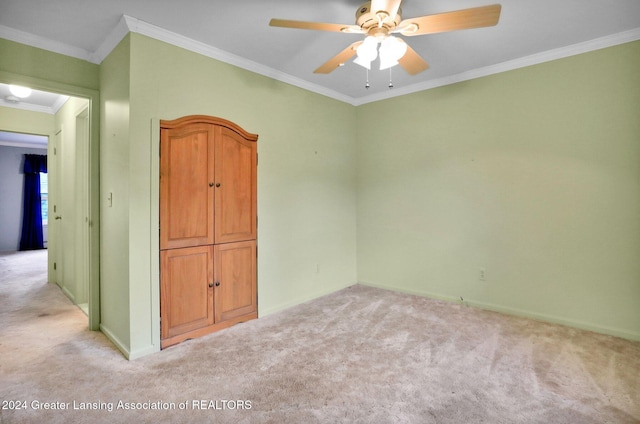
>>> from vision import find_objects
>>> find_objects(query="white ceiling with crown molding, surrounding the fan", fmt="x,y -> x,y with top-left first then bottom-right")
0,0 -> 640,104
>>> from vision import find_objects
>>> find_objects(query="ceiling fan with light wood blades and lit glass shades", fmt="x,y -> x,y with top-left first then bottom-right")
269,0 -> 501,75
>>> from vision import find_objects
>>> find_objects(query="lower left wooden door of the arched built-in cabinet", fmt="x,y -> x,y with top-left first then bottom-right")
160,246 -> 214,339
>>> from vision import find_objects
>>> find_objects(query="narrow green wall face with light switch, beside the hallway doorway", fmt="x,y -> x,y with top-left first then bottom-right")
100,37 -> 131,354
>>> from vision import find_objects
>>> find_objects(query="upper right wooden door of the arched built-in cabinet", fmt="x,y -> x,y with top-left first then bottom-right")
215,127 -> 257,244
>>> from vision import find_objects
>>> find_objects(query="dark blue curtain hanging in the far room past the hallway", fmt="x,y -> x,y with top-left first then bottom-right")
20,155 -> 47,250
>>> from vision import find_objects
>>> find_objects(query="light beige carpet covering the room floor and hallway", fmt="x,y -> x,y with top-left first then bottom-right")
0,252 -> 640,424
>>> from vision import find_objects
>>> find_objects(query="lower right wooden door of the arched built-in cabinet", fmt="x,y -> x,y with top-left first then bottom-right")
214,241 -> 257,323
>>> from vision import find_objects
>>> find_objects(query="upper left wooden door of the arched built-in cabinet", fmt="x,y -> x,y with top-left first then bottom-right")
160,124 -> 214,249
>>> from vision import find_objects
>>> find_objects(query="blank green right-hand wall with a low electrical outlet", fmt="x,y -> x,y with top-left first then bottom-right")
357,42 -> 640,339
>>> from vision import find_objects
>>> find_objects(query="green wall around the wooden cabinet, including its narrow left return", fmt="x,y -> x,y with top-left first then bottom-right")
102,34 -> 357,358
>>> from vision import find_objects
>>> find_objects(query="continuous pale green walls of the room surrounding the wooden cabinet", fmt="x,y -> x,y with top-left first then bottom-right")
0,34 -> 640,358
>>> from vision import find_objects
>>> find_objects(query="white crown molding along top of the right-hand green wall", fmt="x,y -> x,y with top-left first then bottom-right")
352,28 -> 640,106
